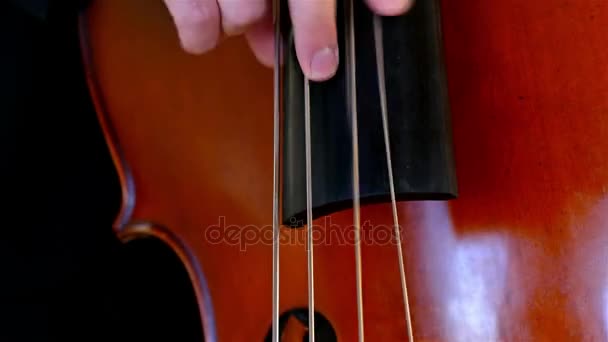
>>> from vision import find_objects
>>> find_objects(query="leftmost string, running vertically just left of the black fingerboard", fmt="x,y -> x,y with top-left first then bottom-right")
272,0 -> 282,342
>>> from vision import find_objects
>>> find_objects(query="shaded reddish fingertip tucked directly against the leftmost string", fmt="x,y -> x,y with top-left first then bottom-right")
245,15 -> 275,68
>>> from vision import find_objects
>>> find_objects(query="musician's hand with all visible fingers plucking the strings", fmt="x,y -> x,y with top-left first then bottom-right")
164,0 -> 414,81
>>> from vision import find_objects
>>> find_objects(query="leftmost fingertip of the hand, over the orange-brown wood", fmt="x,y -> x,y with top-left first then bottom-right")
164,0 -> 221,54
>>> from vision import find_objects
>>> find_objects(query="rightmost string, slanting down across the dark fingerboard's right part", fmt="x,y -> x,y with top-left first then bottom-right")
374,15 -> 414,342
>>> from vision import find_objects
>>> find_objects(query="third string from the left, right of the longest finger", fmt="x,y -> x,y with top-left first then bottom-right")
345,0 -> 365,342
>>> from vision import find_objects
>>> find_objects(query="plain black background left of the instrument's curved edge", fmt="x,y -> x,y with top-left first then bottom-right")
0,0 -> 201,342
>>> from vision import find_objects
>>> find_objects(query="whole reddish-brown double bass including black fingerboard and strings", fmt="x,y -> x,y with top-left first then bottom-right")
80,0 -> 608,341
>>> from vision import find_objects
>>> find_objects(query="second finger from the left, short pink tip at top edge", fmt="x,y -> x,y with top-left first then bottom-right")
218,0 -> 269,36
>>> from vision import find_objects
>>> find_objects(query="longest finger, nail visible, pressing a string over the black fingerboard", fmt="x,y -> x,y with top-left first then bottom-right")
289,0 -> 339,81
